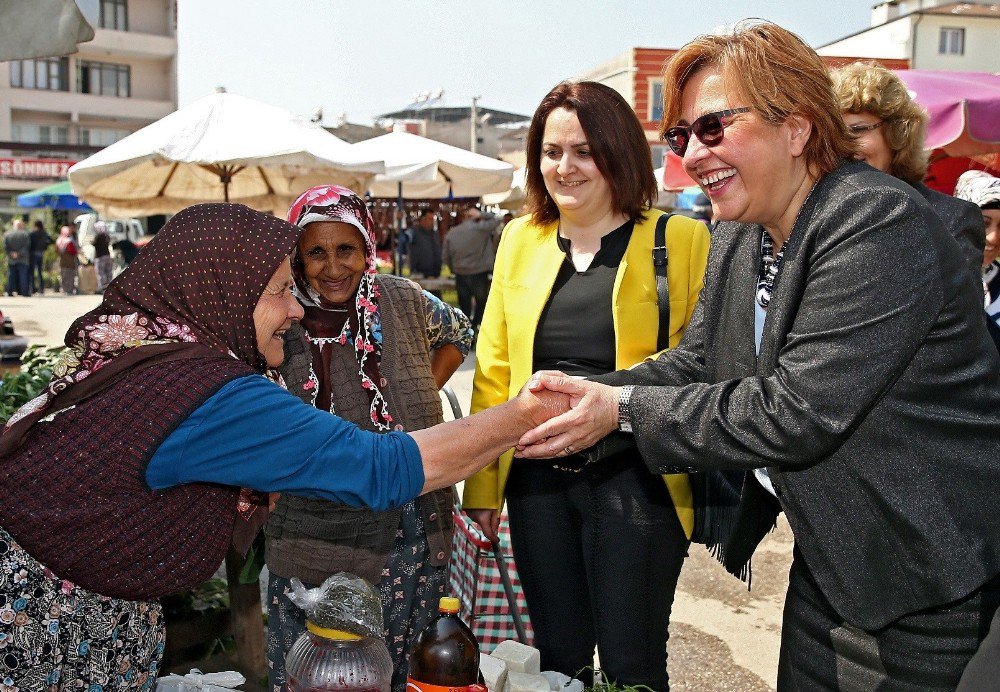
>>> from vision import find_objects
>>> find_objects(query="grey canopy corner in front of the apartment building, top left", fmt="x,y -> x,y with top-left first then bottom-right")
0,0 -> 94,61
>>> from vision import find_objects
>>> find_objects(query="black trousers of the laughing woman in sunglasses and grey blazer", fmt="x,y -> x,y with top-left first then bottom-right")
778,550 -> 1000,692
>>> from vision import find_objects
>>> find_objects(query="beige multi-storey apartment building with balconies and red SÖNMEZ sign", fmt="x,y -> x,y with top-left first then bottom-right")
0,0 -> 177,217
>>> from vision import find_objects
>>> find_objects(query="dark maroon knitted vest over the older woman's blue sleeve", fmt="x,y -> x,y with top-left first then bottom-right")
0,354 -> 253,600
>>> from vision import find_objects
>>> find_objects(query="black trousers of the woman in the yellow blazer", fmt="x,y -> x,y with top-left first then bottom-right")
506,454 -> 689,691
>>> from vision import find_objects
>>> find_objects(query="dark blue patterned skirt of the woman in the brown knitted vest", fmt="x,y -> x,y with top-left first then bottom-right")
267,501 -> 448,692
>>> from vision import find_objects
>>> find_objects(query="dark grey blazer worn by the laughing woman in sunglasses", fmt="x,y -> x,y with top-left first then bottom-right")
595,162 -> 1000,629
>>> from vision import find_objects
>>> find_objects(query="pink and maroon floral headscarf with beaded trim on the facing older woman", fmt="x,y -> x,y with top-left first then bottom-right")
287,185 -> 394,430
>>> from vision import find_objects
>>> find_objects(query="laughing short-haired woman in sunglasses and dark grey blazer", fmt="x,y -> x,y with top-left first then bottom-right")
519,23 -> 1000,690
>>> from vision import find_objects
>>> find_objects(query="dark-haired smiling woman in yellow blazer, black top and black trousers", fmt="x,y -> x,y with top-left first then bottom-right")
464,82 -> 708,690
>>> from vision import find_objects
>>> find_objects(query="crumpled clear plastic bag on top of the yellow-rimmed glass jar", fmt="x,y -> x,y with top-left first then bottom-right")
288,572 -> 383,637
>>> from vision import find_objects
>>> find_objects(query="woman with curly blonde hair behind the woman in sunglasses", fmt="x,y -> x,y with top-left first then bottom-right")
832,62 -> 985,275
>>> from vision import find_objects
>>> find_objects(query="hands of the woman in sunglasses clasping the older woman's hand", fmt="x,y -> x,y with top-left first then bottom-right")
515,371 -> 621,459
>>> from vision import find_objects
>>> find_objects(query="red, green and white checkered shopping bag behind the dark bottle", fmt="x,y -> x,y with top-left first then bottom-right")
451,507 -> 534,653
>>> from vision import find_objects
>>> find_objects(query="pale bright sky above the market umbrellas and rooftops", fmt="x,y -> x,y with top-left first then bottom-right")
178,0 -> 873,124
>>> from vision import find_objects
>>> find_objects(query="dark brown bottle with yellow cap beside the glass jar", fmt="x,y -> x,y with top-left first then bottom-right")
407,597 -> 479,692
